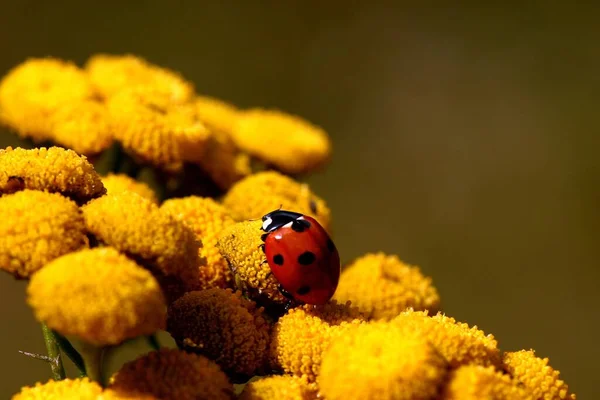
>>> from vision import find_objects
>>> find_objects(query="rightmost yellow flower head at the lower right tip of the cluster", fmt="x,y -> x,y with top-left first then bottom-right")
503,350 -> 576,400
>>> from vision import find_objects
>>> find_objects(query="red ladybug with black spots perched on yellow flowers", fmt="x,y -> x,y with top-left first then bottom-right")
261,209 -> 341,308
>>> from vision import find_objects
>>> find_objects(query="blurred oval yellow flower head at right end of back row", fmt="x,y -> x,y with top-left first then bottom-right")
232,108 -> 331,174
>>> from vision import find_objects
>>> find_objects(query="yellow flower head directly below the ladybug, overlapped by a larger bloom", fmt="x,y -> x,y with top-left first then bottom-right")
269,301 -> 364,382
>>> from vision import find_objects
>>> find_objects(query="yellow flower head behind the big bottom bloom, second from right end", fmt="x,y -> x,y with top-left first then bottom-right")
391,310 -> 500,368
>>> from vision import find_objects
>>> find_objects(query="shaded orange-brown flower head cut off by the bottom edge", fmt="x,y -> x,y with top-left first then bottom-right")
105,349 -> 234,400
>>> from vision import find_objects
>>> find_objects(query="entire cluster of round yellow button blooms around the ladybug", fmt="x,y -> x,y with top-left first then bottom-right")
0,55 -> 575,400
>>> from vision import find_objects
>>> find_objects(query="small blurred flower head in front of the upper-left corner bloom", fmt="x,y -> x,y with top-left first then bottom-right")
51,100 -> 113,155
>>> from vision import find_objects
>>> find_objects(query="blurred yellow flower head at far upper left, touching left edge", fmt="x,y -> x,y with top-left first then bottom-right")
0,58 -> 94,142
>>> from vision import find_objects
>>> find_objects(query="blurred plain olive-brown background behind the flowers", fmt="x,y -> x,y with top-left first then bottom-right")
0,0 -> 600,399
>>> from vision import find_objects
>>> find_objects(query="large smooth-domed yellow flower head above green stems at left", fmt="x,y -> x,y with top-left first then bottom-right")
27,247 -> 166,345
